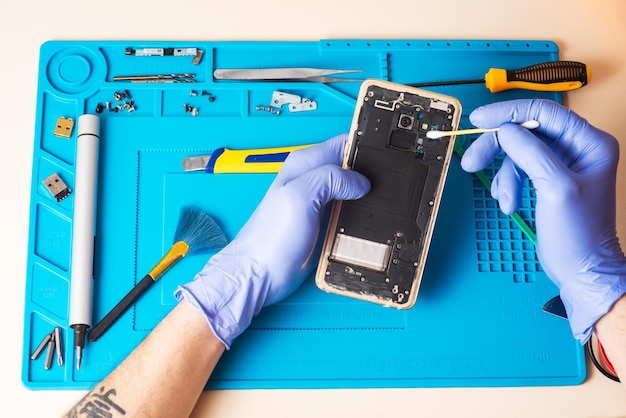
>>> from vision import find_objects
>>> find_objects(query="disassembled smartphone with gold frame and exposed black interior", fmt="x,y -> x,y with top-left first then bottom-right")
316,80 -> 461,309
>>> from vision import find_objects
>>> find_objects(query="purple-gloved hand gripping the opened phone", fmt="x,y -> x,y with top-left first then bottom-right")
174,135 -> 370,349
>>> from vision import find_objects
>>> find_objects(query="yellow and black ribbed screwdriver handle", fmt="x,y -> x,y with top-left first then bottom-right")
485,61 -> 591,93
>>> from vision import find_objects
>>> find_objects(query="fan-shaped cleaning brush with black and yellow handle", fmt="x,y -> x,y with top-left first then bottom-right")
87,206 -> 228,342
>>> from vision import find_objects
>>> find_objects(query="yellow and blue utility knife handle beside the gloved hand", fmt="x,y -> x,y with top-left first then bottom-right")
205,144 -> 312,174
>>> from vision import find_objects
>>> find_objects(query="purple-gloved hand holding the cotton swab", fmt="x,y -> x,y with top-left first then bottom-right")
461,100 -> 626,343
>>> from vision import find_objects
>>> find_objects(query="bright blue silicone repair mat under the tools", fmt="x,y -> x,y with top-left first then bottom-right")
22,40 -> 586,389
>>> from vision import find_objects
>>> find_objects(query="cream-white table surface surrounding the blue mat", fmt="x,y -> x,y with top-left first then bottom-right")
0,0 -> 626,418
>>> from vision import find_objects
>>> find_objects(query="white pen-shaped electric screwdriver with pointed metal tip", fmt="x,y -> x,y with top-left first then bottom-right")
70,114 -> 100,369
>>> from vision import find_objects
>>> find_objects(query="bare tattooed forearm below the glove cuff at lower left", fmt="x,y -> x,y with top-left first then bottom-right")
59,300 -> 226,418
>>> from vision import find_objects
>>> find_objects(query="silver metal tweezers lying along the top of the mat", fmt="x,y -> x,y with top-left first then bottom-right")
213,67 -> 363,83
